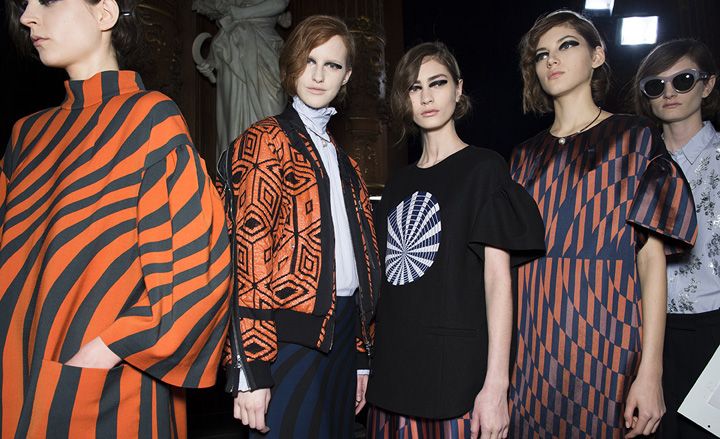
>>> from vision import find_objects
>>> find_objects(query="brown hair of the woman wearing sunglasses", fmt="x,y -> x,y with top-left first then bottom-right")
632,38 -> 720,125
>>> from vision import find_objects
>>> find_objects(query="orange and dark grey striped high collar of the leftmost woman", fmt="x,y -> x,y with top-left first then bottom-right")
61,70 -> 145,109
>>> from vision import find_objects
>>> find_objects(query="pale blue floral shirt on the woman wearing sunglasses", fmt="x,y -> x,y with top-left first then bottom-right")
667,122 -> 720,314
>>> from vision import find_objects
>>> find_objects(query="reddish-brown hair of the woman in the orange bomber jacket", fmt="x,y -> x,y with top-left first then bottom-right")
279,15 -> 355,101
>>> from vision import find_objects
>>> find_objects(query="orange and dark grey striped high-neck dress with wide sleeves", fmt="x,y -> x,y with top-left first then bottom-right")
0,71 -> 230,438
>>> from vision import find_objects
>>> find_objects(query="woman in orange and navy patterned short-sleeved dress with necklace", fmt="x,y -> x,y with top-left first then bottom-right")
510,10 -> 695,439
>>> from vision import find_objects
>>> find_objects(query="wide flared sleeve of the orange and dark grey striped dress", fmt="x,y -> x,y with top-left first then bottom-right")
101,145 -> 230,387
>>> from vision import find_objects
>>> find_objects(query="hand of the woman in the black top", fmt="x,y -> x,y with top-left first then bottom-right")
470,385 -> 510,439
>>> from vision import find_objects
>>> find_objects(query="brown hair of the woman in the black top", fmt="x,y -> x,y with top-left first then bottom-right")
390,41 -> 472,140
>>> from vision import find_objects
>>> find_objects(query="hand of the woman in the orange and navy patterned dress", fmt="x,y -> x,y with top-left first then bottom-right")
624,374 -> 665,438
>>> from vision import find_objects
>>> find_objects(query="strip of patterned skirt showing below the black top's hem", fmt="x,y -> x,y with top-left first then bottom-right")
367,406 -> 470,439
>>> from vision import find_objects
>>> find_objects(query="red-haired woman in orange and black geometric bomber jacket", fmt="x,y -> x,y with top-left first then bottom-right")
221,16 -> 378,438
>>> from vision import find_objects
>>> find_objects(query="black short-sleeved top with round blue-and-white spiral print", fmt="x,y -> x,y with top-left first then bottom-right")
368,146 -> 544,419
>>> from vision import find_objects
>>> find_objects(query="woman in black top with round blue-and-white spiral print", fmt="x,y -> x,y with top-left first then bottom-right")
368,43 -> 543,438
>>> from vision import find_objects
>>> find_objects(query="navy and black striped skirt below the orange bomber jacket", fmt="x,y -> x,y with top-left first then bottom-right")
250,297 -> 357,439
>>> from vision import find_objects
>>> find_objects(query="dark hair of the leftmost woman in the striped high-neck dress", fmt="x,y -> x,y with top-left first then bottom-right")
5,0 -> 142,67
